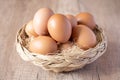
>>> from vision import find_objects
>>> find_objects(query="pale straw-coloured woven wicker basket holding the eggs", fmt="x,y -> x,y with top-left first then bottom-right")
16,25 -> 107,72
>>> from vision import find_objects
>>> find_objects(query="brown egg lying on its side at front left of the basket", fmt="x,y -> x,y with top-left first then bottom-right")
29,36 -> 57,55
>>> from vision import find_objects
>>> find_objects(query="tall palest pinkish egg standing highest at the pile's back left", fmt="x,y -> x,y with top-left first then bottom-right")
33,8 -> 54,35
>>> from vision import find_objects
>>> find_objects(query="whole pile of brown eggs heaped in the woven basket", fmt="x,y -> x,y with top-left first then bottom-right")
25,8 -> 97,55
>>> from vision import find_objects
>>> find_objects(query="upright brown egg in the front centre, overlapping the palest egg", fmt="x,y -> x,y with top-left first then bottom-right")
48,14 -> 72,43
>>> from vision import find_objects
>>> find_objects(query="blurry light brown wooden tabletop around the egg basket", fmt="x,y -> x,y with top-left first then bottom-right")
0,0 -> 120,80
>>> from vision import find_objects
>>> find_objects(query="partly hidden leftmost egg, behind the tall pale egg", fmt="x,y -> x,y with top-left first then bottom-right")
25,20 -> 38,37
